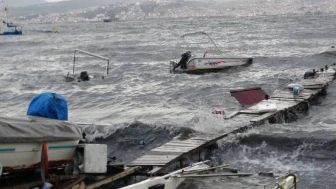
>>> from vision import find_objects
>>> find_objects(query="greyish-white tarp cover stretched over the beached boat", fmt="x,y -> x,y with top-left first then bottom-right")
0,116 -> 82,143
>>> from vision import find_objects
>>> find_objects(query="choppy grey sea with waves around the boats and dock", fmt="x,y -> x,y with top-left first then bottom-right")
0,15 -> 336,189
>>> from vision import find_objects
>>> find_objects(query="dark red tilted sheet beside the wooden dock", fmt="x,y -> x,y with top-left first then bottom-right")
230,87 -> 267,106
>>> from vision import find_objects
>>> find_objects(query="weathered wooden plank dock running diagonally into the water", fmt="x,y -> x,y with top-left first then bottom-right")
127,72 -> 335,174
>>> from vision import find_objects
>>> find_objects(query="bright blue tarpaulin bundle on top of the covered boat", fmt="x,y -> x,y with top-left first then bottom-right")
27,92 -> 68,121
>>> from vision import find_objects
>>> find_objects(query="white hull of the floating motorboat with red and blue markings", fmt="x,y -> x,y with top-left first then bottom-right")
171,57 -> 253,74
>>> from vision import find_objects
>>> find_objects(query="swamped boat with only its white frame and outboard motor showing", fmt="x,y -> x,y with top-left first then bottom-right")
64,49 -> 110,82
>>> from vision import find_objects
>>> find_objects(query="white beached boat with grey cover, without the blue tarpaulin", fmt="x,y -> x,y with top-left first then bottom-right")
0,116 -> 82,173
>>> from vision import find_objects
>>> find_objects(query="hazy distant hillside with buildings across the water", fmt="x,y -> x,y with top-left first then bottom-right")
5,0 -> 336,23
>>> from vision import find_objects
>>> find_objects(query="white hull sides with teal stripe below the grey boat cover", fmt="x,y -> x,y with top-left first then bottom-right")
0,140 -> 79,172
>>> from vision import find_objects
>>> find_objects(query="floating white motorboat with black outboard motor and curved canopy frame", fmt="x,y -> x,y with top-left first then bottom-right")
169,32 -> 253,74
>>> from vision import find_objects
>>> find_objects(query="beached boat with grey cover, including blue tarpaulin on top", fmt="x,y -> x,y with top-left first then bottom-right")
0,92 -> 83,172
